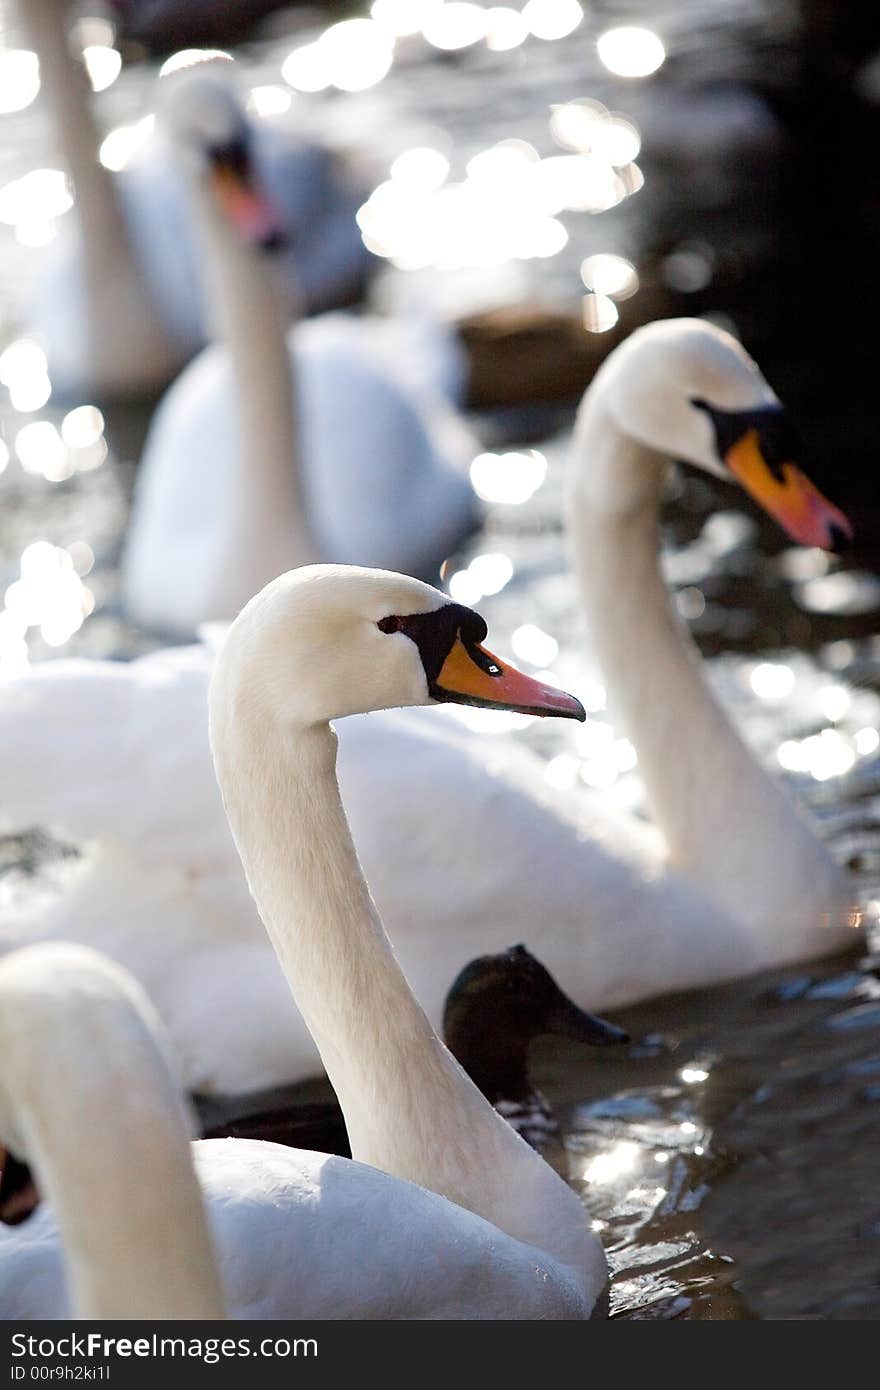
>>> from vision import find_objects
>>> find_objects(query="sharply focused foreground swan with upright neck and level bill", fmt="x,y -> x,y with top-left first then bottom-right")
1,566 -> 608,1318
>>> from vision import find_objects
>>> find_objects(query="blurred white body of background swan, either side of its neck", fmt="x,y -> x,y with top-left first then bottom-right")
124,314 -> 477,634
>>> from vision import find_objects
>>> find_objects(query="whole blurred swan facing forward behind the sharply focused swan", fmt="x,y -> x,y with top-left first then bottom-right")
122,72 -> 478,632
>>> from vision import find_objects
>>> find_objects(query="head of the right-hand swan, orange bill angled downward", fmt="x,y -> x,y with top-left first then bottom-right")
584,318 -> 852,549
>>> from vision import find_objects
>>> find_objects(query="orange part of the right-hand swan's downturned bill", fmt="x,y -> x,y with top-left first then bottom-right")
724,428 -> 852,550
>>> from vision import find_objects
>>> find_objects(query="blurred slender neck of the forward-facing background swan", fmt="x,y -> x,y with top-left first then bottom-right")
195,186 -> 318,592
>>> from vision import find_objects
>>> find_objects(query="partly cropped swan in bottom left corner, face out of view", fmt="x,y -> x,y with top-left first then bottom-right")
0,942 -> 224,1319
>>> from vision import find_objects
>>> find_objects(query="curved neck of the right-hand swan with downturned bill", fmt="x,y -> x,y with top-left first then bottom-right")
569,392 -> 841,937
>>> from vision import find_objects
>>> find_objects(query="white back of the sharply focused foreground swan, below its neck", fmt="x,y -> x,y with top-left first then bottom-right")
6,1138 -> 589,1321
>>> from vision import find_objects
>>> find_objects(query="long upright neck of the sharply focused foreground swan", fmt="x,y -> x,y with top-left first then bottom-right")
211,689 -> 595,1273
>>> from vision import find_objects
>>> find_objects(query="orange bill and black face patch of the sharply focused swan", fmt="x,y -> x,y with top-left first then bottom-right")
378,603 -> 587,720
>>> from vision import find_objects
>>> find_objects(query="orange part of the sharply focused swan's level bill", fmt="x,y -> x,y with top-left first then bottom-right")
431,637 -> 587,721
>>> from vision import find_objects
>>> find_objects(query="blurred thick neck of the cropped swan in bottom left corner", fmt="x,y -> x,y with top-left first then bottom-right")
0,998 -> 225,1319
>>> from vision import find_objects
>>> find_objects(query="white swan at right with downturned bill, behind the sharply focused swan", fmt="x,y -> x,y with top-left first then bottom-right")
0,321 -> 858,1091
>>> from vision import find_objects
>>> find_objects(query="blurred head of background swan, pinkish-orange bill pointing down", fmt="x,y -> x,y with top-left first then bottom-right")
160,63 -> 286,250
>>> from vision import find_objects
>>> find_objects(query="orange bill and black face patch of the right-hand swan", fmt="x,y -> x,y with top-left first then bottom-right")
692,400 -> 852,550
